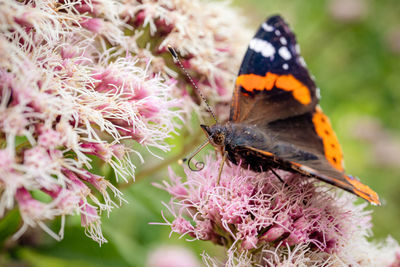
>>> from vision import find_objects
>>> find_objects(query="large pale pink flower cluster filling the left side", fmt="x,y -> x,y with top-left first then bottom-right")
0,1 -> 181,244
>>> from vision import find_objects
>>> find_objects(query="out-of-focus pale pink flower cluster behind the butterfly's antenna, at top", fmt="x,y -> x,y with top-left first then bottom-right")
122,0 -> 251,121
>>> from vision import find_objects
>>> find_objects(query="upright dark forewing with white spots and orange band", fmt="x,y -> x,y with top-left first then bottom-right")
230,16 -> 318,125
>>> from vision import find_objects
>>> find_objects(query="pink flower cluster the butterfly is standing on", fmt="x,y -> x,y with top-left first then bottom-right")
158,157 -> 399,266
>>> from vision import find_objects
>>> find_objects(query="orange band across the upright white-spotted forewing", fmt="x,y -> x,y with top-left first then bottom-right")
236,72 -> 311,105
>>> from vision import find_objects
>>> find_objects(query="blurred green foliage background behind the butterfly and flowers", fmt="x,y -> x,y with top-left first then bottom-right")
0,0 -> 400,267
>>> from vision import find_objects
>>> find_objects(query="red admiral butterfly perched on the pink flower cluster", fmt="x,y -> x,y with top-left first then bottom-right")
171,16 -> 380,205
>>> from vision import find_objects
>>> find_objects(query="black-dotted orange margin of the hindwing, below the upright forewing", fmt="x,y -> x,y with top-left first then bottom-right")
312,107 -> 344,171
